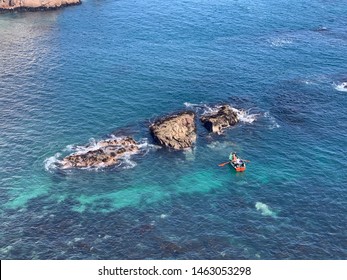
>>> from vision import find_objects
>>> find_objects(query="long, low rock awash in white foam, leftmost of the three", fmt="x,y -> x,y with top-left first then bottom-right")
61,137 -> 139,168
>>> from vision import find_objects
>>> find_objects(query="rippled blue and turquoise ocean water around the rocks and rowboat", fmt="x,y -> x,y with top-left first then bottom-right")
0,0 -> 347,259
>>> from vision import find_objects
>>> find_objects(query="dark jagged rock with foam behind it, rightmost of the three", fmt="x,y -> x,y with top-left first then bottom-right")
200,105 -> 238,134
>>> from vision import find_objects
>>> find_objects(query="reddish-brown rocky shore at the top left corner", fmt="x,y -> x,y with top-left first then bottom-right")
0,0 -> 82,11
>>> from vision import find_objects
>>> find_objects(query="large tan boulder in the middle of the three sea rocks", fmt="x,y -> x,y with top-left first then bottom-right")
150,112 -> 196,150
